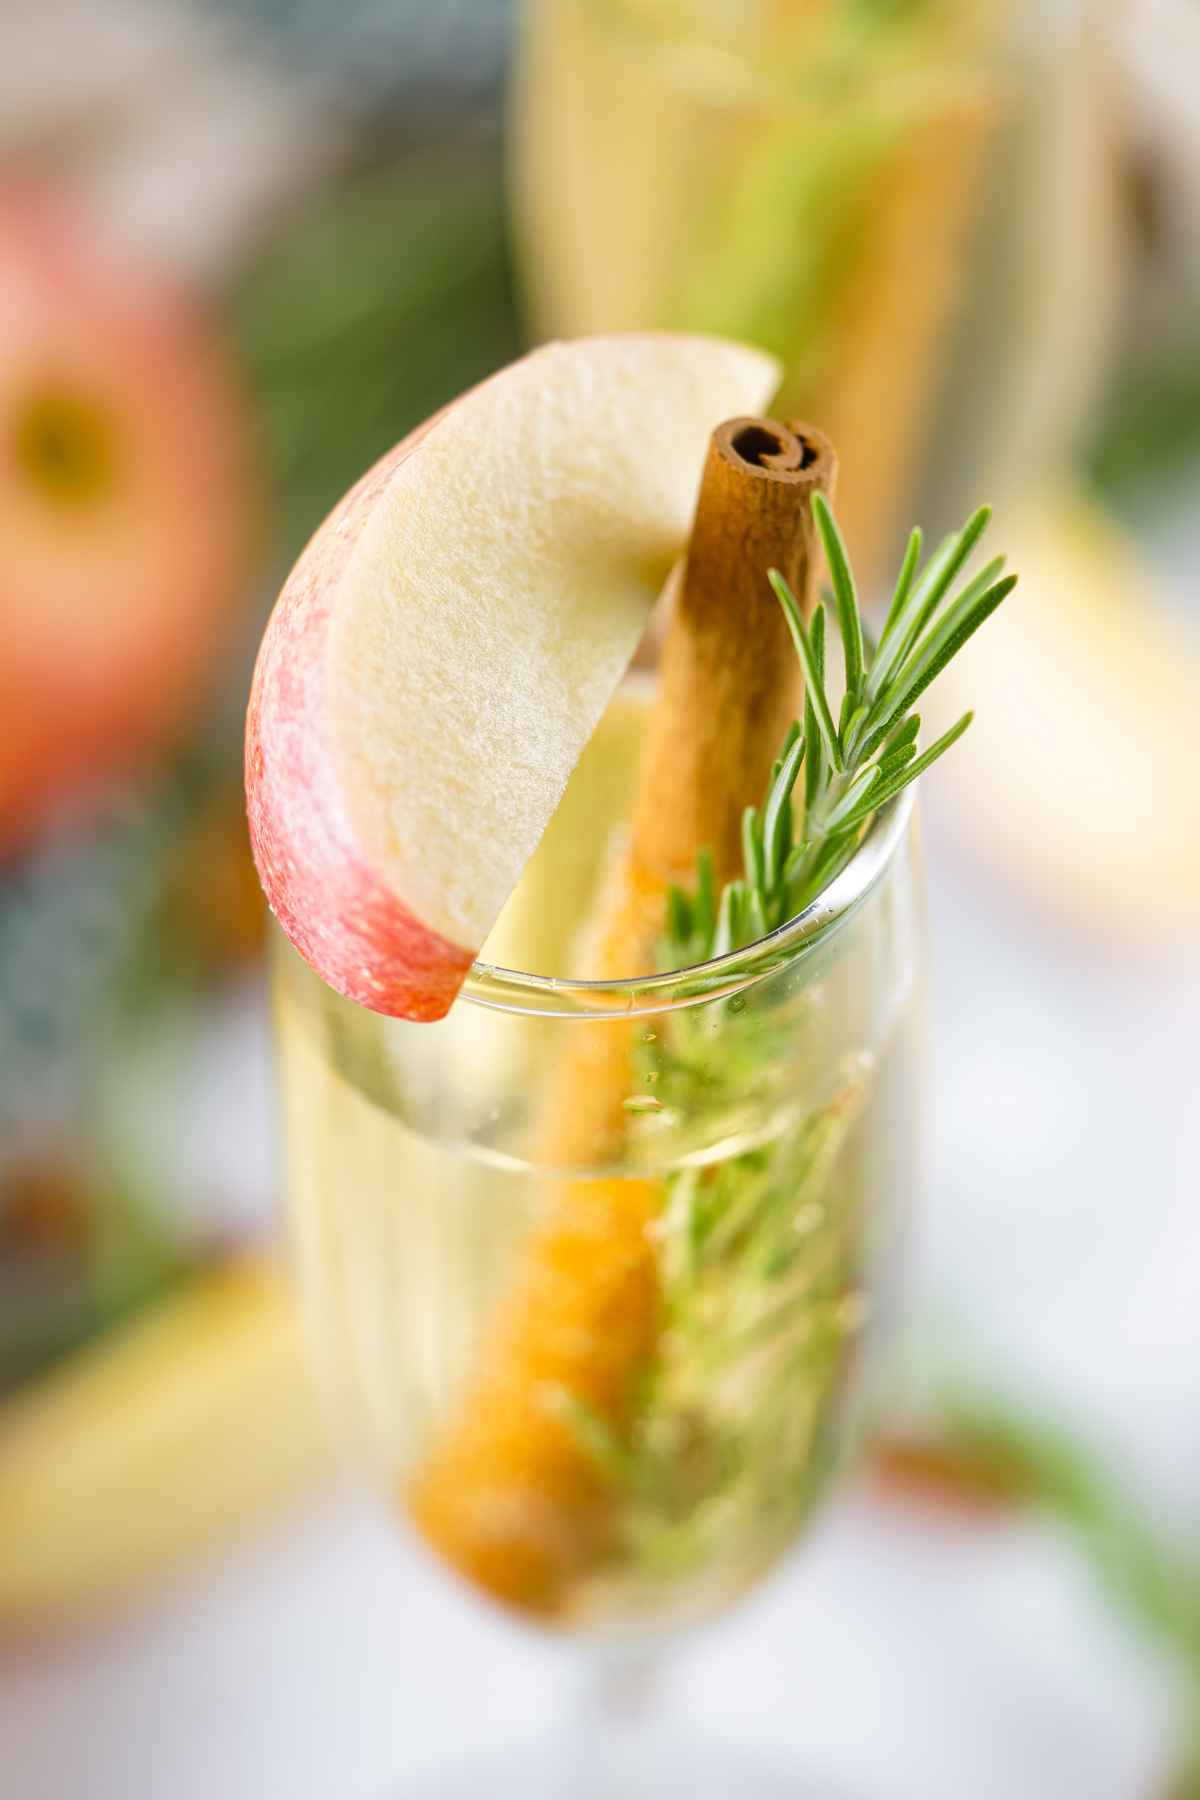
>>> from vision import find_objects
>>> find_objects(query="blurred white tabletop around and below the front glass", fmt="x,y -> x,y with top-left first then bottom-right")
0,792 -> 1200,1800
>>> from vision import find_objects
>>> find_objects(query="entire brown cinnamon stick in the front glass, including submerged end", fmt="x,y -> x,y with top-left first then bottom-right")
408,419 -> 835,1613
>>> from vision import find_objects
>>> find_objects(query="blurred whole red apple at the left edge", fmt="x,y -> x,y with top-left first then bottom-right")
0,184 -> 257,855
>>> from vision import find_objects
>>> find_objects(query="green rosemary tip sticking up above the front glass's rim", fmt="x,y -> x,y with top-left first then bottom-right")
662,493 -> 1016,968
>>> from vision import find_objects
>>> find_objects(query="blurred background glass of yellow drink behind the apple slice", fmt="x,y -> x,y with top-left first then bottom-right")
511,0 -> 1123,578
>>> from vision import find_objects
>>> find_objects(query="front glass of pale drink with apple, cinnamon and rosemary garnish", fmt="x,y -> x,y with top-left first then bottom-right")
246,335 -> 1013,1728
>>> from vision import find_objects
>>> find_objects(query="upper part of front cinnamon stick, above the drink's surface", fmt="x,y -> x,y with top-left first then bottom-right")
538,418 -> 837,1168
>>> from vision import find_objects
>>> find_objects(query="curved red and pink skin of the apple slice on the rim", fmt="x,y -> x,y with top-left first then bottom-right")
246,414 -> 473,1021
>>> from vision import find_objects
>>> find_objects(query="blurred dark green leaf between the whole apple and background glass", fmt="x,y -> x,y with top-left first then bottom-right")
232,149 -> 518,562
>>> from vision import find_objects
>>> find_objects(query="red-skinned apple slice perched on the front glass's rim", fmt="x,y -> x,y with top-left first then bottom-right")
246,335 -> 777,1019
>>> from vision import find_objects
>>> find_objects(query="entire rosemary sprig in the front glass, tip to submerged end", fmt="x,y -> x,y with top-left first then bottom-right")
564,499 -> 1013,1584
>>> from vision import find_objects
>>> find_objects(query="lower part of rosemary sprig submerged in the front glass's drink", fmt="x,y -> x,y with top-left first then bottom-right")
551,1064 -> 871,1586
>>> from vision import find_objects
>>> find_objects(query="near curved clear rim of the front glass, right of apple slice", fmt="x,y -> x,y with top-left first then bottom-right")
459,785 -> 914,1019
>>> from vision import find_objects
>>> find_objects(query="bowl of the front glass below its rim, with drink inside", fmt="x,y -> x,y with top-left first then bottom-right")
275,695 -> 923,1742
